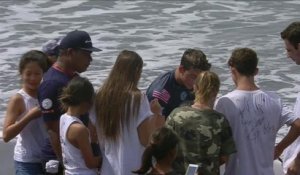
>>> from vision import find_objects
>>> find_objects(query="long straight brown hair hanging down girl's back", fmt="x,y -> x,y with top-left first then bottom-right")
95,50 -> 143,141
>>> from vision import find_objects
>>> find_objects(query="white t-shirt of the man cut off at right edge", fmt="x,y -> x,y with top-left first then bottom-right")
283,92 -> 300,175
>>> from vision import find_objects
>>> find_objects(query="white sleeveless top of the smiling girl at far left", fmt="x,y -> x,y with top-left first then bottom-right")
14,89 -> 47,163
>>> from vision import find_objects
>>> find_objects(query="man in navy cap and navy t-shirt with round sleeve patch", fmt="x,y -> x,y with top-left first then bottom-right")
38,30 -> 101,174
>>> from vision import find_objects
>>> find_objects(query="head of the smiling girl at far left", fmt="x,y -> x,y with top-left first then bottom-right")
19,50 -> 47,90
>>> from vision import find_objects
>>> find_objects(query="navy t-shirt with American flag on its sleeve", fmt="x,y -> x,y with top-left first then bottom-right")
146,70 -> 195,117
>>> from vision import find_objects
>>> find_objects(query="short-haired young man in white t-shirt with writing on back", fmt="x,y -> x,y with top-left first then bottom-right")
215,48 -> 300,175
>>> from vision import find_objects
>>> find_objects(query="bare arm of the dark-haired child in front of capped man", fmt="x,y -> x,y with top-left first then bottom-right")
67,123 -> 101,168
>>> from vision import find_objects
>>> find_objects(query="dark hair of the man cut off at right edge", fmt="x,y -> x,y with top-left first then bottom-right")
280,21 -> 300,49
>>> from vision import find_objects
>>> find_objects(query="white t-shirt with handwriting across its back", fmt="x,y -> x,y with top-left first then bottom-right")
215,90 -> 296,175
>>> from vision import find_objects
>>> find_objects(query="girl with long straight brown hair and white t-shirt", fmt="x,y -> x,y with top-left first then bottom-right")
90,50 -> 165,175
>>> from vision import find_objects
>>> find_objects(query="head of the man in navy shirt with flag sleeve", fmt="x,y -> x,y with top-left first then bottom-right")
177,49 -> 211,89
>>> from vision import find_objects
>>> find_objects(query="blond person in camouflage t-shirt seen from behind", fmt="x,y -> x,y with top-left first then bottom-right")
166,71 -> 236,175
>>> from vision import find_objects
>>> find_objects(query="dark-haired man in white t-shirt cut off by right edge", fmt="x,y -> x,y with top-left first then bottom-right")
281,21 -> 300,175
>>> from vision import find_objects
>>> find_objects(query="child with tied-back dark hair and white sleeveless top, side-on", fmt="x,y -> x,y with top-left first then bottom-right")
59,76 -> 101,175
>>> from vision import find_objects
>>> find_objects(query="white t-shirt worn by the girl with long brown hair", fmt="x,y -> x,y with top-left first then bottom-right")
90,95 -> 152,175
